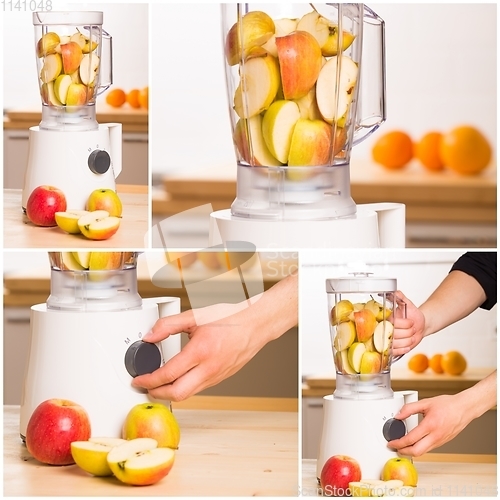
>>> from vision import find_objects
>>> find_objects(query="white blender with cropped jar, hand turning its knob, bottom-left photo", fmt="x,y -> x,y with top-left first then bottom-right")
20,252 -> 180,439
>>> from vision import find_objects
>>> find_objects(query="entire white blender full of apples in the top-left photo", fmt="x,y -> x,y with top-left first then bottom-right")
22,11 -> 122,211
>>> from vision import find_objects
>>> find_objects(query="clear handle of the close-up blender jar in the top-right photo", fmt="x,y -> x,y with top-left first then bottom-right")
353,5 -> 386,145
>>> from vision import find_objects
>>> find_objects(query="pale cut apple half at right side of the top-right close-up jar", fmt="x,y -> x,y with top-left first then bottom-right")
316,56 -> 358,124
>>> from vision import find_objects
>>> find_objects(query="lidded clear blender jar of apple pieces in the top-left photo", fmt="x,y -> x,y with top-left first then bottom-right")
33,11 -> 112,130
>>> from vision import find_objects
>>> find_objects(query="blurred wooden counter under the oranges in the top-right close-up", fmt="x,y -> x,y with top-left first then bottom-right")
152,160 -> 497,224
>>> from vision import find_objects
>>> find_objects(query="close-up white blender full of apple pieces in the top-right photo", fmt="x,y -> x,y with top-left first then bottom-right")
211,3 -> 405,248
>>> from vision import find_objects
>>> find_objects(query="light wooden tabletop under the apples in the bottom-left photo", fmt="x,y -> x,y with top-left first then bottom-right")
3,406 -> 299,497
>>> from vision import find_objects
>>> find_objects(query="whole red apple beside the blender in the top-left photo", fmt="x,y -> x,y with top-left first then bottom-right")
26,185 -> 66,227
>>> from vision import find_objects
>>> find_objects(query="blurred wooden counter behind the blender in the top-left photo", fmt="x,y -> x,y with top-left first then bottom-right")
3,103 -> 149,134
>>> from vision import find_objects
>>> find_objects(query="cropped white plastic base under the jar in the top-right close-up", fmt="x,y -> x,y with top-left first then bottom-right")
209,203 -> 406,248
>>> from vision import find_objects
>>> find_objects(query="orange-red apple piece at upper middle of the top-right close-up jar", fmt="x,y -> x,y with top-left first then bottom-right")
276,31 -> 322,99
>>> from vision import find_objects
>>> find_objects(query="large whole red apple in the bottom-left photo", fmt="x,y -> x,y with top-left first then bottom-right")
26,398 -> 91,465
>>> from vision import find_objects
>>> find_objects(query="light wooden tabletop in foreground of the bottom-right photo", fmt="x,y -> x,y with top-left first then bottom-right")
301,453 -> 497,498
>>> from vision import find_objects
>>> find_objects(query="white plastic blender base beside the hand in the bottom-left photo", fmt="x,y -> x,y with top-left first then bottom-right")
20,297 -> 181,437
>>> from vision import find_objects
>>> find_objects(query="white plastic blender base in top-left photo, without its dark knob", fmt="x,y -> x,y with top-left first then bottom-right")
22,123 -> 122,210
